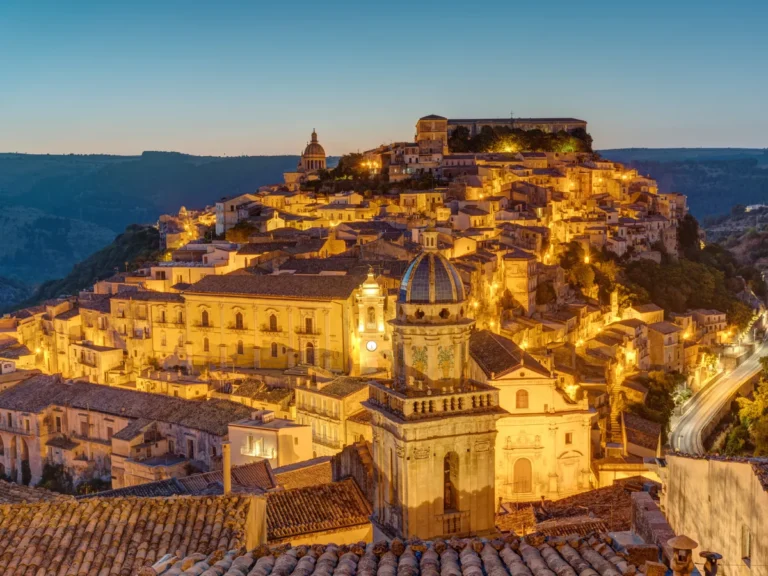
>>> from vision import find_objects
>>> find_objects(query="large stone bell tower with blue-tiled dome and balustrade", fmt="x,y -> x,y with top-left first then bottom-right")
365,241 -> 506,539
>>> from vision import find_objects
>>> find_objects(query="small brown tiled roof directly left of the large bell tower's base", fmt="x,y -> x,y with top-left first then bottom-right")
267,478 -> 371,541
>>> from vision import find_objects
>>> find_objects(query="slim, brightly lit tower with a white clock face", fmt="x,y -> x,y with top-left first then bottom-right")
357,268 -> 392,374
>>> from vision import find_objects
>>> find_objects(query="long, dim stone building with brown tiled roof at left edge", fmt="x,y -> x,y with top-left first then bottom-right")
0,375 -> 251,487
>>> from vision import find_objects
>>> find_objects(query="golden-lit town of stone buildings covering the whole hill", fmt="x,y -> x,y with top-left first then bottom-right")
0,115 -> 768,576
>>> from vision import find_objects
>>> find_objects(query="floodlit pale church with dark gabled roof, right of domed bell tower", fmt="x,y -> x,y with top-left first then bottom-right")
470,330 -> 597,501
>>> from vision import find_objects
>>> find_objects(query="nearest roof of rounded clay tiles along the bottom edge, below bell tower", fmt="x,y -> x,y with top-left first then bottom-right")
147,534 -> 637,576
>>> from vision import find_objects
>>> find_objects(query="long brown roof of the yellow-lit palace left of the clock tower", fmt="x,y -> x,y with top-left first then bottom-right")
187,274 -> 365,300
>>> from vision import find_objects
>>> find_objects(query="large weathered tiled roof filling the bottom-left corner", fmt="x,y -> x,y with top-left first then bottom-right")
0,496 -> 253,576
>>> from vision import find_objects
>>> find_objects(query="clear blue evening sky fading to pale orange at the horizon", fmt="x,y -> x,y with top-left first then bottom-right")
0,0 -> 768,155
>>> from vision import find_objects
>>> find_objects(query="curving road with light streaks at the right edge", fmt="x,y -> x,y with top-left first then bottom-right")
669,341 -> 768,454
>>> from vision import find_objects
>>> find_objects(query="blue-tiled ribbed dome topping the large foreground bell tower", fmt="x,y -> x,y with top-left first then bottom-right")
398,250 -> 465,304
